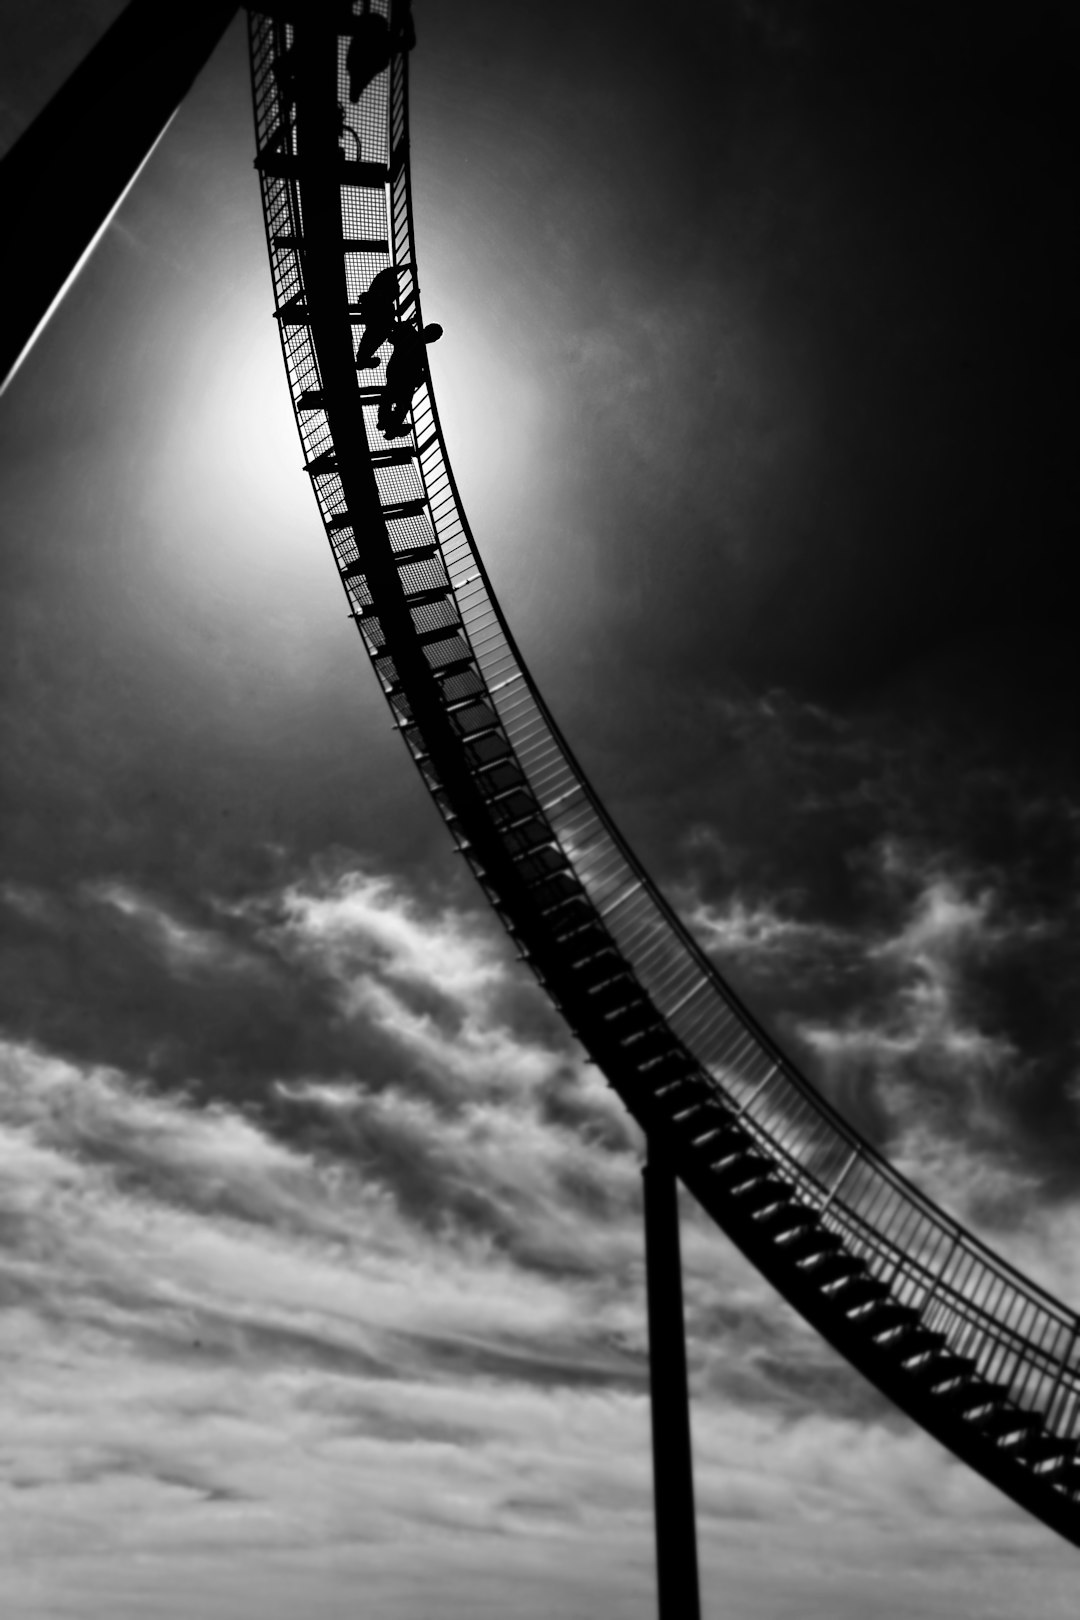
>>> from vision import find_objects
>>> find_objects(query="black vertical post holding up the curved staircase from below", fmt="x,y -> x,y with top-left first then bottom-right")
641,1137 -> 701,1620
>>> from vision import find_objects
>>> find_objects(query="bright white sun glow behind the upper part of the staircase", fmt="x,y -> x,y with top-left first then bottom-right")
133,234 -> 563,696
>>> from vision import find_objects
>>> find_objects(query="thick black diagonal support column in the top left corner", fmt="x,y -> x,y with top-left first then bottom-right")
0,0 -> 236,392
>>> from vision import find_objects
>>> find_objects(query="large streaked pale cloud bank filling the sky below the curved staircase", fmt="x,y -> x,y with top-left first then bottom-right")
0,835 -> 1069,1620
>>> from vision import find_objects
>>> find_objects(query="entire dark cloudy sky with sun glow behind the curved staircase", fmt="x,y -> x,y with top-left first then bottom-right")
0,0 -> 1080,1620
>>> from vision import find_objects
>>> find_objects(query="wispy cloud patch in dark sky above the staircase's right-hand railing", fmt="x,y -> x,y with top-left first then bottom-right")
667,822 -> 1080,1315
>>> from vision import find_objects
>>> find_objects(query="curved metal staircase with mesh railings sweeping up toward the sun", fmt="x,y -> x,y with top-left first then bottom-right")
251,0 -> 1080,1544
